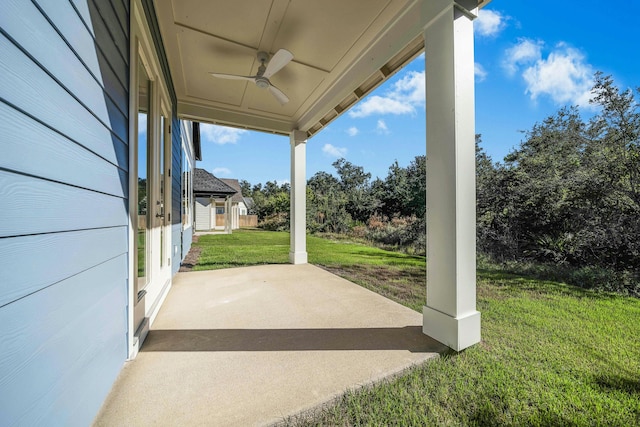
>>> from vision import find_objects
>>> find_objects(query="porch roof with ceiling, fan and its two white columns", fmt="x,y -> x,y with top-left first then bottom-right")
149,0 -> 489,351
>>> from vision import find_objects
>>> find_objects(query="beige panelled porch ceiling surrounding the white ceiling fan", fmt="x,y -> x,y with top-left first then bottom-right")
154,0 -> 489,136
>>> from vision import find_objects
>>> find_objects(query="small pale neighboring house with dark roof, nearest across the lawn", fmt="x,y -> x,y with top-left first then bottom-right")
193,168 -> 237,233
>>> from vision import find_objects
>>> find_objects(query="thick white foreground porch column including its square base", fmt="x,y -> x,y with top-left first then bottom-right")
423,0 -> 480,351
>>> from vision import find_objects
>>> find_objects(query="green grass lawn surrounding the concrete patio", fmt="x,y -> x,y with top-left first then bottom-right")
190,231 -> 640,426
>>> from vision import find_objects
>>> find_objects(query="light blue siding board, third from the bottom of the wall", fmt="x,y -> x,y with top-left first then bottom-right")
0,170 -> 128,237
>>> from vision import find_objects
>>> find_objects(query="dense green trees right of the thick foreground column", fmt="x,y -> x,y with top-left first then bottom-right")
476,73 -> 640,273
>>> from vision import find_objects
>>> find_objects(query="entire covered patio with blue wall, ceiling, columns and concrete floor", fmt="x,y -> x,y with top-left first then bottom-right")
0,0 -> 489,425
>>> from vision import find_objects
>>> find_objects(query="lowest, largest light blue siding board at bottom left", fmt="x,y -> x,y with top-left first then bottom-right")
0,255 -> 127,426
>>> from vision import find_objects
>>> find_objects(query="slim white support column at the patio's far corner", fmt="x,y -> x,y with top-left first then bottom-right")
289,130 -> 307,264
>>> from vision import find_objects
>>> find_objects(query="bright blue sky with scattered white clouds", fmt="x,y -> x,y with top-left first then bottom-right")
197,0 -> 640,184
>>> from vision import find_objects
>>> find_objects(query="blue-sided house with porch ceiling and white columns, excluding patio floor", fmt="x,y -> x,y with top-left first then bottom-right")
0,0 -> 488,426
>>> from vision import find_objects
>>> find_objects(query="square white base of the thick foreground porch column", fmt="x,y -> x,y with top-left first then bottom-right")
422,306 -> 480,351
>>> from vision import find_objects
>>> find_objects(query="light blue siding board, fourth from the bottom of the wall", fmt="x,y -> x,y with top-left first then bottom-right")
0,103 -> 129,197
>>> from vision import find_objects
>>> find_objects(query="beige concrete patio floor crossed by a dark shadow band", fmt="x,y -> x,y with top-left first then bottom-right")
94,265 -> 446,426
